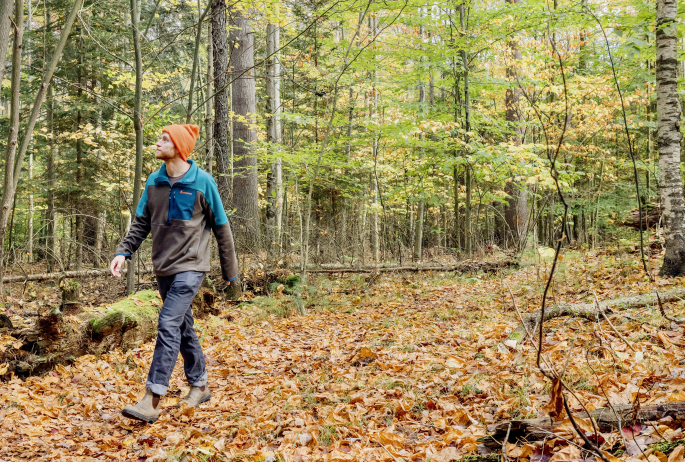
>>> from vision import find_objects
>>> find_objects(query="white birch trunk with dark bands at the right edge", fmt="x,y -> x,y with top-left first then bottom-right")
656,0 -> 685,276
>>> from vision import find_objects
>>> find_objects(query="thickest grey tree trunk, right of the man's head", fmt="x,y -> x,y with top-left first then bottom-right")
229,9 -> 259,250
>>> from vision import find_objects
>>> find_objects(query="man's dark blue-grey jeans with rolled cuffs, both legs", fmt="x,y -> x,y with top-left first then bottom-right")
145,271 -> 207,395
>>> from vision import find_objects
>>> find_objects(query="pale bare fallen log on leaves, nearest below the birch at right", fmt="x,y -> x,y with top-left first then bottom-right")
503,287 -> 685,348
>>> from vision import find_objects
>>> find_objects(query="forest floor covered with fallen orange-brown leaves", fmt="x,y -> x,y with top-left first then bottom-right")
0,252 -> 685,462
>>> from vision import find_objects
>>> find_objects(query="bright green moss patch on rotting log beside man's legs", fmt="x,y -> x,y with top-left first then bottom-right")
90,290 -> 160,336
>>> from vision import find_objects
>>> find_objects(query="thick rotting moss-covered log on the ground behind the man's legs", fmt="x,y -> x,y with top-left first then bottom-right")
0,287 -> 218,376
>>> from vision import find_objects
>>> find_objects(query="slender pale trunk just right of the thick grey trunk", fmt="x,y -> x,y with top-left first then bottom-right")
266,24 -> 283,260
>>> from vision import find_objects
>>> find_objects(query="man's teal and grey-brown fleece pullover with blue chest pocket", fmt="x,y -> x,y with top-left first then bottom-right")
117,160 -> 238,281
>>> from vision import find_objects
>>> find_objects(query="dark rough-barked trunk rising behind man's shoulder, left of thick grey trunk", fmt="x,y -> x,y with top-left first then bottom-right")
212,0 -> 231,202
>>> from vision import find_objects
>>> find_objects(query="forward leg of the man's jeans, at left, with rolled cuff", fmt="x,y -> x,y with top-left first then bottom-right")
146,271 -> 204,395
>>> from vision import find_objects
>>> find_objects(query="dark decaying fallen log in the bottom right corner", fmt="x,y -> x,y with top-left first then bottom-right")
479,401 -> 685,449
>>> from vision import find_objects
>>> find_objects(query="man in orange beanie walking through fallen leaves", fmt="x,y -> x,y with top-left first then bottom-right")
110,125 -> 238,423
